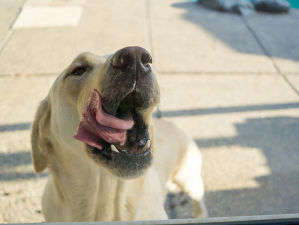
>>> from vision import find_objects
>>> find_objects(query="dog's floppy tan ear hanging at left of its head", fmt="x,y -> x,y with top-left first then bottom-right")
31,98 -> 52,173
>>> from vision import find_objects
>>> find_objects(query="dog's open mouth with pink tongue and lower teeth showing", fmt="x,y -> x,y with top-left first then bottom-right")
74,90 -> 151,160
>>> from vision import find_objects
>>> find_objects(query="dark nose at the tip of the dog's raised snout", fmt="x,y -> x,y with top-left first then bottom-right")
111,46 -> 152,73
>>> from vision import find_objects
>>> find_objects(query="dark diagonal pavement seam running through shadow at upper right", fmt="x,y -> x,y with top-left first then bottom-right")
242,17 -> 299,96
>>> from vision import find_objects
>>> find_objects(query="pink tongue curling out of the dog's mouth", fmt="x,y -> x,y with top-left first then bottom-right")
74,90 -> 134,149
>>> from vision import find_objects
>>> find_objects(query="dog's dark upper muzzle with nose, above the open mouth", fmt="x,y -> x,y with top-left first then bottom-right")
101,47 -> 155,115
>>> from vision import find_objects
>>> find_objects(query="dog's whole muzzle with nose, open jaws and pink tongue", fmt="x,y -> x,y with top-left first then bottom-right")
75,47 -> 159,176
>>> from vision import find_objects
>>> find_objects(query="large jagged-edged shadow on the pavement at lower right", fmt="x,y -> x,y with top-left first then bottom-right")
196,117 -> 299,217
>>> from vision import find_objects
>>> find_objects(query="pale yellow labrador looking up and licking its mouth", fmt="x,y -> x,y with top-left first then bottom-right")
31,47 -> 206,221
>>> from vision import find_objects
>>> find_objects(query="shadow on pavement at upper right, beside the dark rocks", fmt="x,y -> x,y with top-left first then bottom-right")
172,1 -> 299,61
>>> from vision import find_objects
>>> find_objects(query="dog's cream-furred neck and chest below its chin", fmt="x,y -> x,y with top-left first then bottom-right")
48,146 -> 164,221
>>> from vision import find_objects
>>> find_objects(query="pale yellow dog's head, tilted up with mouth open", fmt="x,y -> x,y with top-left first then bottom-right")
31,47 -> 159,177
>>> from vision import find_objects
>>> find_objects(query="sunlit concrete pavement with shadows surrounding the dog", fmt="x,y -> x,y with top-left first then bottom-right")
0,0 -> 299,223
